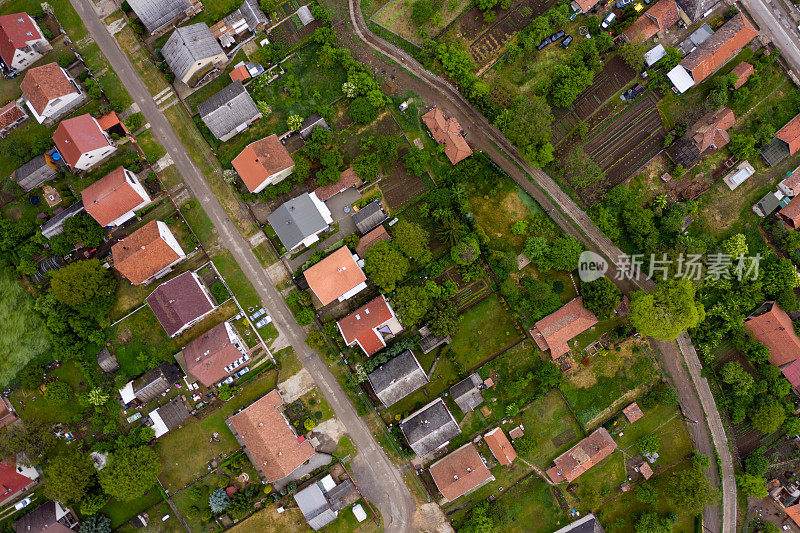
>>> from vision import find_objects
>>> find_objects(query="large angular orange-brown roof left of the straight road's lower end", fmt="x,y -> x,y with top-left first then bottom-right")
228,389 -> 315,482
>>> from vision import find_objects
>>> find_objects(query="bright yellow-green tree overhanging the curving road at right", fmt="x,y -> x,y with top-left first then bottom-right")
629,278 -> 705,341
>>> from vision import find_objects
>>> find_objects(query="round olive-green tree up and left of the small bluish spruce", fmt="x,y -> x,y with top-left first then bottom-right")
100,446 -> 161,502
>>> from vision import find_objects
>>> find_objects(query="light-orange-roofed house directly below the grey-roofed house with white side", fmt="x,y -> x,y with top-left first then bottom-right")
303,246 -> 367,305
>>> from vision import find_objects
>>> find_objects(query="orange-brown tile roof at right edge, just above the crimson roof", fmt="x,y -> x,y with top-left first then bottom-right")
744,302 -> 800,367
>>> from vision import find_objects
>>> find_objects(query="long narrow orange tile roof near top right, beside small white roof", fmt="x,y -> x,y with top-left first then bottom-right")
681,13 -> 758,84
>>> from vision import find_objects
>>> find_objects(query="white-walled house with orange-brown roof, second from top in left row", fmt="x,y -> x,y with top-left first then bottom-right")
19,63 -> 86,124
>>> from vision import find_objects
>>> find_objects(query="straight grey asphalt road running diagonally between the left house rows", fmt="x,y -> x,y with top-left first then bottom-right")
70,0 -> 415,532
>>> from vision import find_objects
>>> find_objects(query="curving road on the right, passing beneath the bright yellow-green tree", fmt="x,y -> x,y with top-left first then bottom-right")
337,0 -> 736,533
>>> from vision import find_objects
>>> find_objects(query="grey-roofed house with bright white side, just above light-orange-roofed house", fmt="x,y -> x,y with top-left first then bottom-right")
267,192 -> 333,252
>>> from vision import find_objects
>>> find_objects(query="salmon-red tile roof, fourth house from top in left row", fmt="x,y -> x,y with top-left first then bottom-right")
81,167 -> 144,226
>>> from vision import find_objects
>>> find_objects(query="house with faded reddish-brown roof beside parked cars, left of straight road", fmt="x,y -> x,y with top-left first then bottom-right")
180,321 -> 250,387
